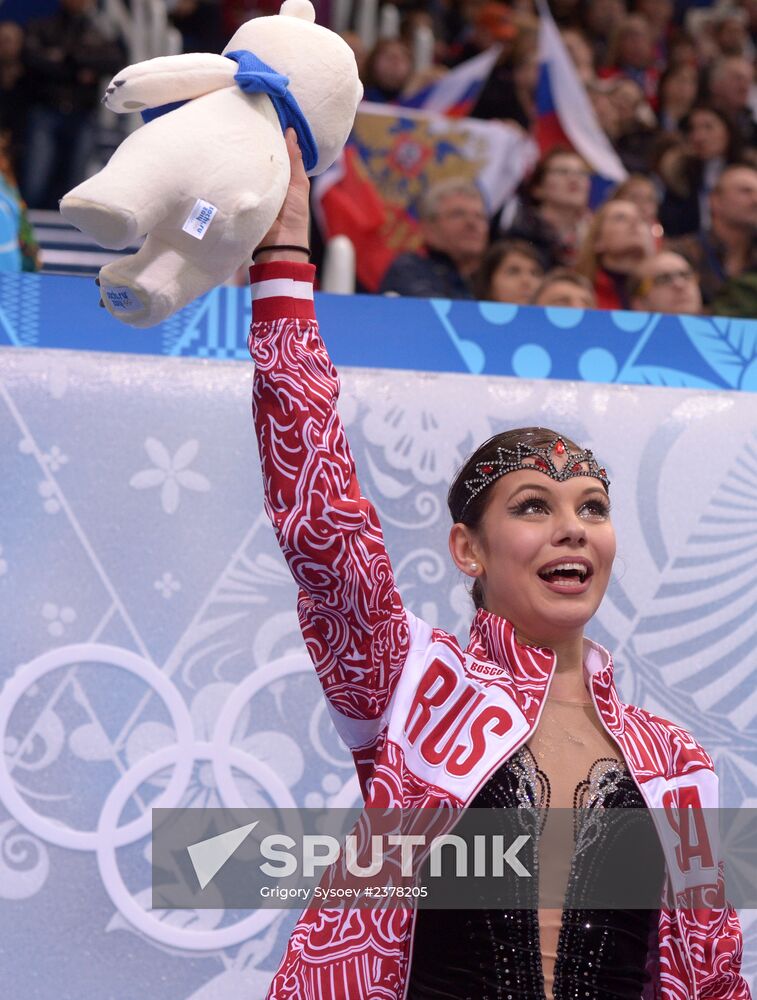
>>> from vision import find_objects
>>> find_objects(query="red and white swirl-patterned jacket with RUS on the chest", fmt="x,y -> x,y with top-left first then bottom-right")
250,263 -> 750,1000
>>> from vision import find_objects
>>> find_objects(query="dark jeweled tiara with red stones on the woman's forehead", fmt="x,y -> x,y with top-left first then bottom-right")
458,438 -> 610,520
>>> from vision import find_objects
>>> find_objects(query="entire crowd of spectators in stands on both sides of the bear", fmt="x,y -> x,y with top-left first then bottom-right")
0,0 -> 757,316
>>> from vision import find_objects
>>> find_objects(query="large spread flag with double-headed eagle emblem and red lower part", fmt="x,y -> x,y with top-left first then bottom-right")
313,103 -> 536,292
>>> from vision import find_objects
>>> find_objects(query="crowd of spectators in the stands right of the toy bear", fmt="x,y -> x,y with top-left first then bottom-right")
356,0 -> 757,317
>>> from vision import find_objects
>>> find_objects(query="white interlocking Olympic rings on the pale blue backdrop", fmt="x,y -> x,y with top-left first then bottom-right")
0,643 -> 312,951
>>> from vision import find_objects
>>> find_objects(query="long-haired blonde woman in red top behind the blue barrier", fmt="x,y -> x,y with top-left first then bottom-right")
576,201 -> 652,309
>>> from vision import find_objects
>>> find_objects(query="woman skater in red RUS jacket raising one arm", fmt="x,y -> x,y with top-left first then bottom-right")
250,130 -> 750,1000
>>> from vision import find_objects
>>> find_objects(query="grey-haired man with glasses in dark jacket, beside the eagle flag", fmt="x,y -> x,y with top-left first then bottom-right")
379,178 -> 489,299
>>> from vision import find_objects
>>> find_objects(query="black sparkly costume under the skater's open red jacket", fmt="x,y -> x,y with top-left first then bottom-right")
407,747 -> 663,1000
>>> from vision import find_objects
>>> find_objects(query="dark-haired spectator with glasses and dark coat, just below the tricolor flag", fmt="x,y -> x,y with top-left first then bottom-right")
504,147 -> 591,267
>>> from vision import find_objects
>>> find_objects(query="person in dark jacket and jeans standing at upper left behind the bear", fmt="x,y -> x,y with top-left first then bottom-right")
22,0 -> 124,208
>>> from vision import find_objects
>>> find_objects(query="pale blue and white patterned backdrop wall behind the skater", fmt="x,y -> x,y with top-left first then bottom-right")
0,282 -> 757,1000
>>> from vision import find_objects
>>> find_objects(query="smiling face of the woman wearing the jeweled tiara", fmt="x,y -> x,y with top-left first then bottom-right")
450,459 -> 615,646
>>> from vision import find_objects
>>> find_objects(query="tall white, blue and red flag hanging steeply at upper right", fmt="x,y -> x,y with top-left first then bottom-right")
535,0 -> 628,206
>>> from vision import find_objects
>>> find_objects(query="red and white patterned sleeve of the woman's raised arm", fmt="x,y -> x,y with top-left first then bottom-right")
249,261 -> 409,719
